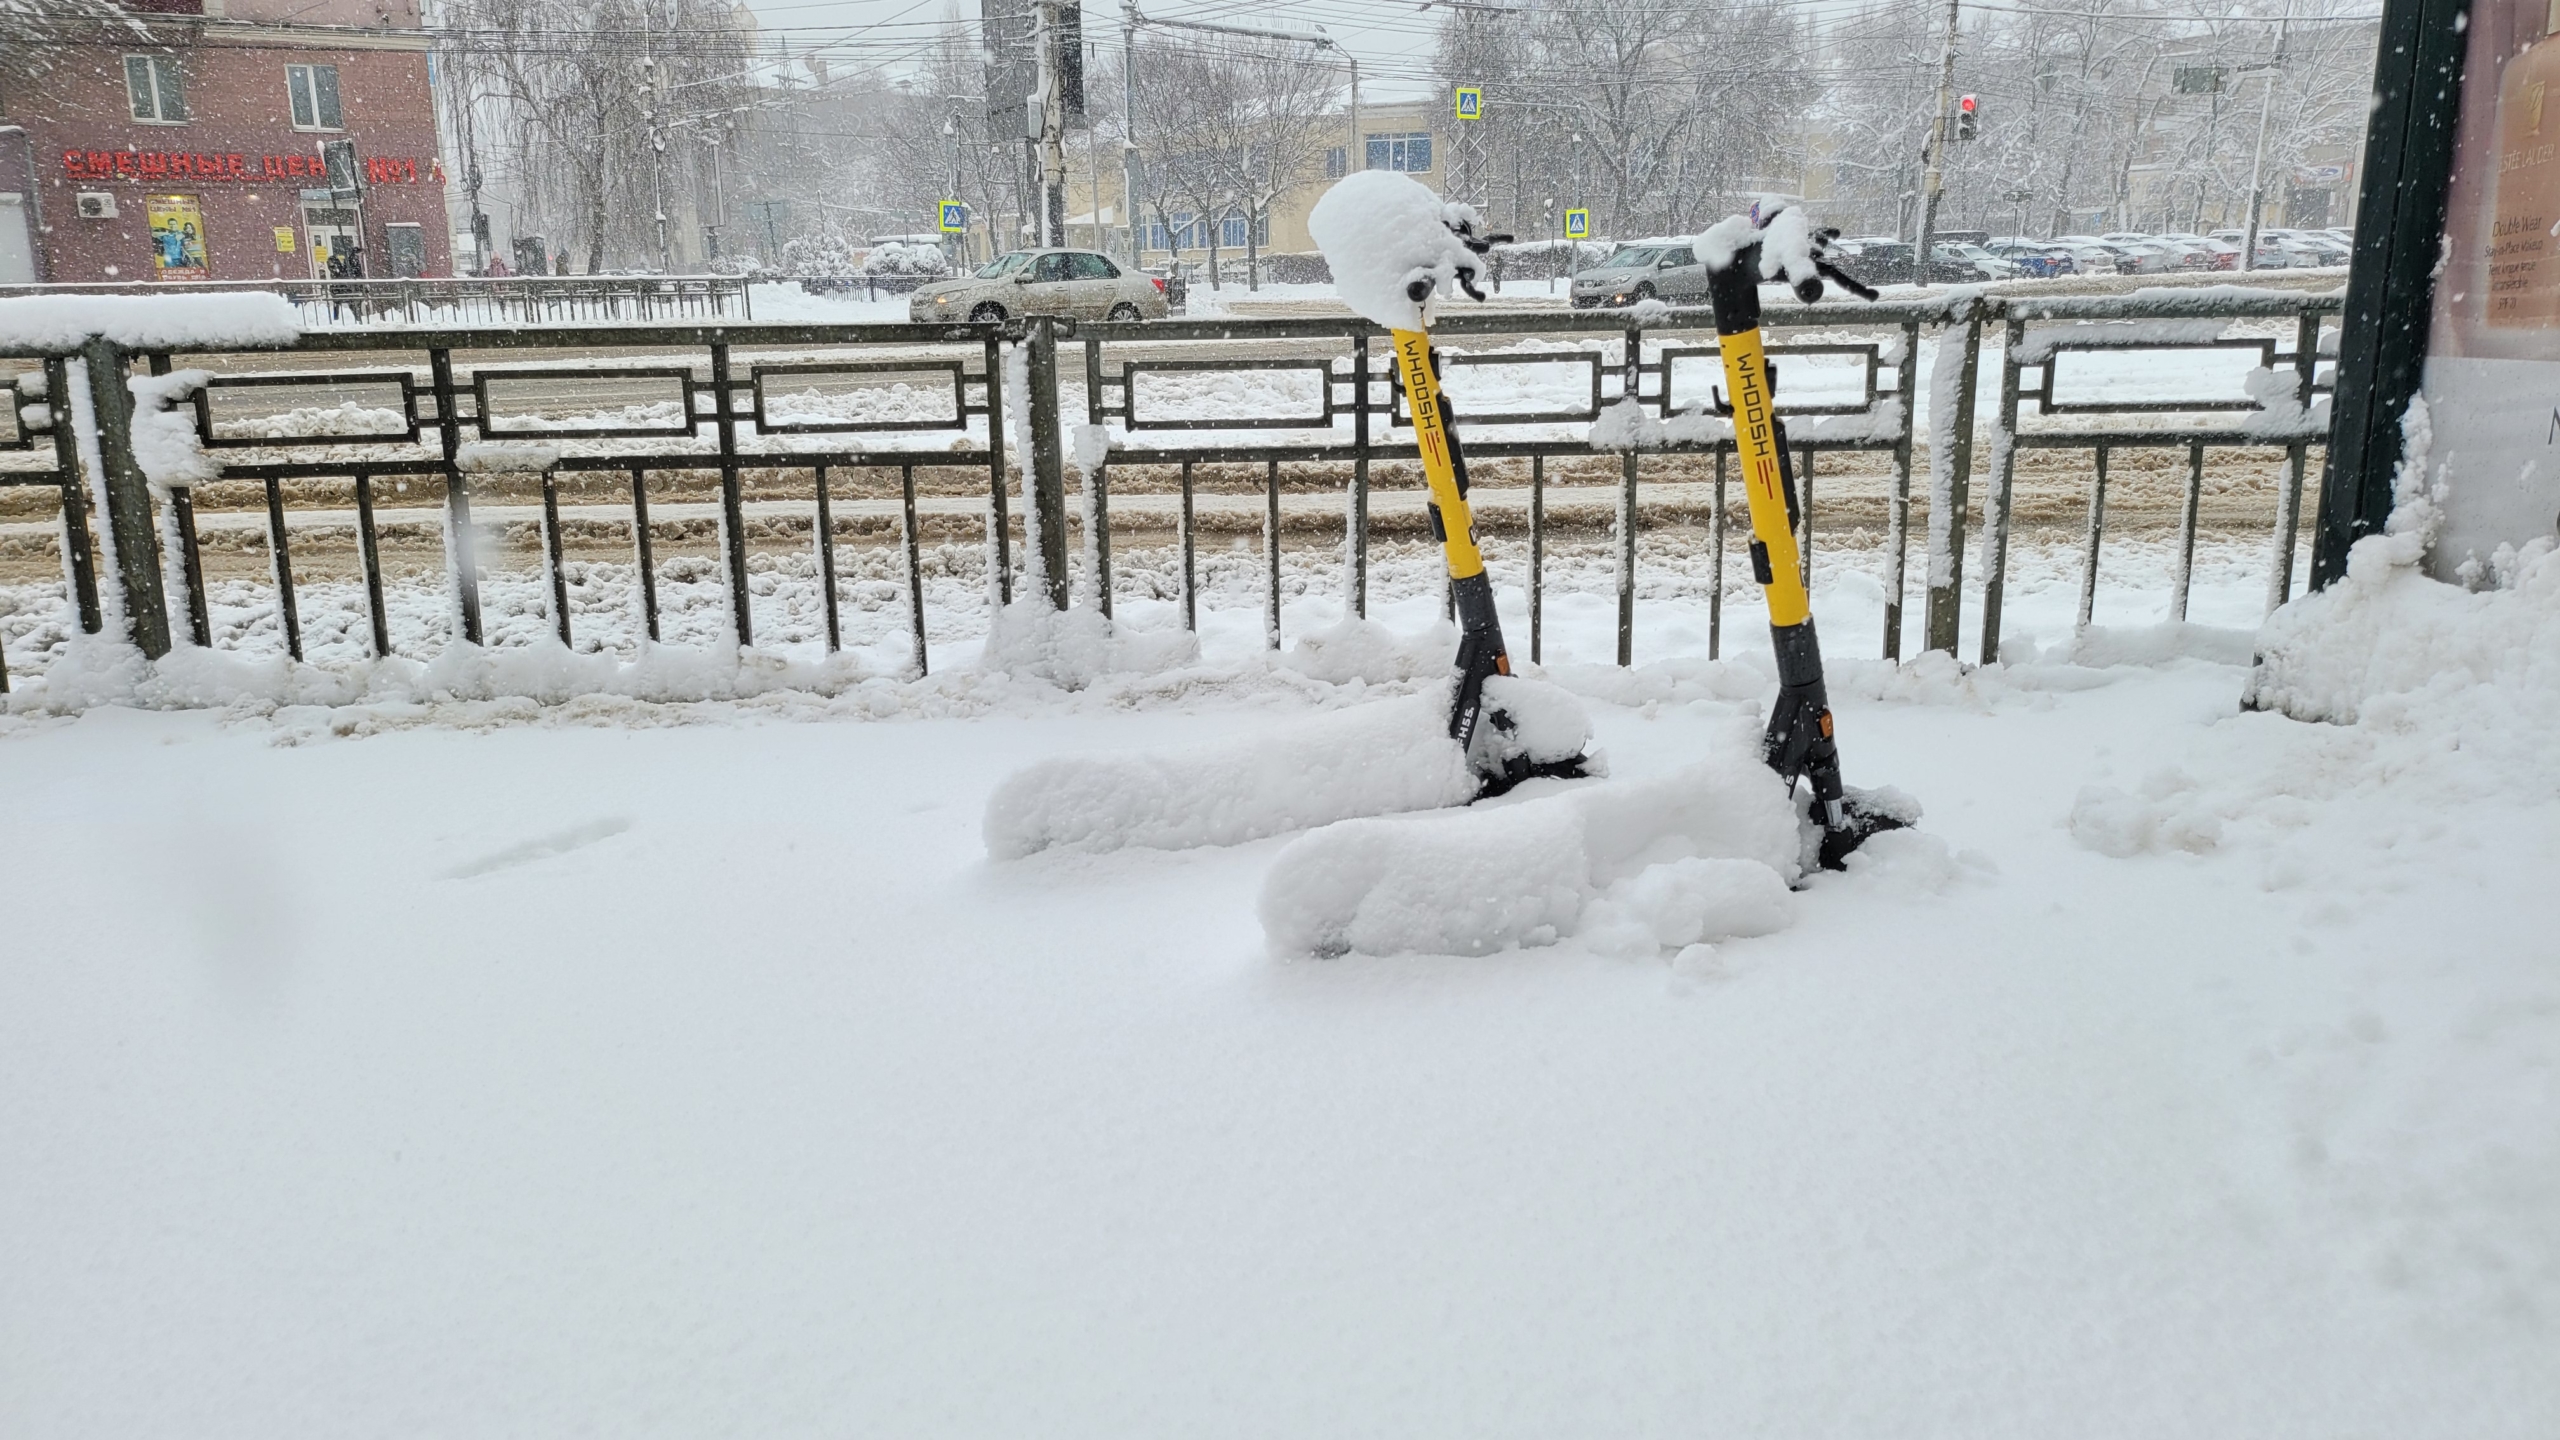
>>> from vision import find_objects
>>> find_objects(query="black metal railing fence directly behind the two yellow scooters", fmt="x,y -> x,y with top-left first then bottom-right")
0,290 -> 2340,687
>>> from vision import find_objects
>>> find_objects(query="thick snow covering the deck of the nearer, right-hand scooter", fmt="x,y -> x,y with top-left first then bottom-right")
1262,756 -> 1802,956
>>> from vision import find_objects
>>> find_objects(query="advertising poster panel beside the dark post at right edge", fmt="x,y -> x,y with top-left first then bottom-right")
2424,0 -> 2560,571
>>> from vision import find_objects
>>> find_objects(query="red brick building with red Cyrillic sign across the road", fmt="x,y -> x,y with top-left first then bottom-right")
0,0 -> 453,282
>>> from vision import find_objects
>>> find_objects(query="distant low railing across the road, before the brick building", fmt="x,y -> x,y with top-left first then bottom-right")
0,274 -> 755,331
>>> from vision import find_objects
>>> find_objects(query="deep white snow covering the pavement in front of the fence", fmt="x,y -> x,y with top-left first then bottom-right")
0,517 -> 2560,1440
